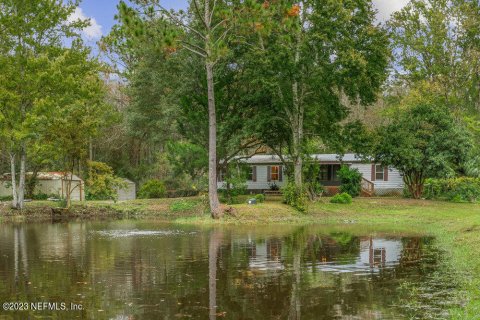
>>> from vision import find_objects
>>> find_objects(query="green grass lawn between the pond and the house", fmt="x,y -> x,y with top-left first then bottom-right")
0,197 -> 480,319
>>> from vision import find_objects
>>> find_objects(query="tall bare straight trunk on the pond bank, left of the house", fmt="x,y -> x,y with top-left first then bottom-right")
204,0 -> 222,219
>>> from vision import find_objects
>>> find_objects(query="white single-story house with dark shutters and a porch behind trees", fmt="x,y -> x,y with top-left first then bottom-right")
218,153 -> 404,196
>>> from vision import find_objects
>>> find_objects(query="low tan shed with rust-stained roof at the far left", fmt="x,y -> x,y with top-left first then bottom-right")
0,172 -> 85,201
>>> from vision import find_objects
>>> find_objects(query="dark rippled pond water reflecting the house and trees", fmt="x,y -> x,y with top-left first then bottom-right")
0,221 -> 455,319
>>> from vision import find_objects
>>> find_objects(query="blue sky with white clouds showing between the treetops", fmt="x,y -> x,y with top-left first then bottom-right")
71,0 -> 409,44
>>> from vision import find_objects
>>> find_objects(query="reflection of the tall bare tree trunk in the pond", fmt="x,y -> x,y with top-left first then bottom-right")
208,231 -> 222,320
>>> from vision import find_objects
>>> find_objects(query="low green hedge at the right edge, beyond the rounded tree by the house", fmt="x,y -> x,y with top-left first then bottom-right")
423,177 -> 480,202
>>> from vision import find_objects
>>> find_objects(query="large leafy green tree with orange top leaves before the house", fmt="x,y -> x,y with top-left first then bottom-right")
236,0 -> 390,196
